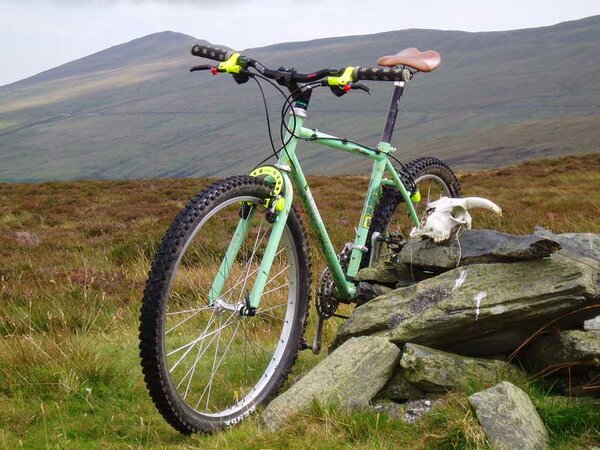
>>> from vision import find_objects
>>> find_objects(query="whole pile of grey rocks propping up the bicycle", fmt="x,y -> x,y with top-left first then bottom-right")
263,228 -> 600,448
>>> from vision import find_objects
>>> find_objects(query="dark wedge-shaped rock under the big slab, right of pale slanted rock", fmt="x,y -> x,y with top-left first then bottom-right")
400,343 -> 519,394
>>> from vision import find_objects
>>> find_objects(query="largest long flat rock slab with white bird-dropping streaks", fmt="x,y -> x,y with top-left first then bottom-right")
332,257 -> 600,356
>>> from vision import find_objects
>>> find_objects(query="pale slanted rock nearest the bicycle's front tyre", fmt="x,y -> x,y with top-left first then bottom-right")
262,337 -> 400,430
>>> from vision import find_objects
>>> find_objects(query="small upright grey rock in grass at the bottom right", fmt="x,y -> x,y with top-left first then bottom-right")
469,381 -> 549,450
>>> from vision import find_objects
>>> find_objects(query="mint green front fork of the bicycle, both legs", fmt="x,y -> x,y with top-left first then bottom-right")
208,167 -> 294,316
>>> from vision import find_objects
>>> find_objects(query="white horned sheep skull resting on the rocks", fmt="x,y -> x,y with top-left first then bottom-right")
410,197 -> 502,243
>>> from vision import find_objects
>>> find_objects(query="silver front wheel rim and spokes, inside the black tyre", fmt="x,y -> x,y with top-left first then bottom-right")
162,196 -> 298,418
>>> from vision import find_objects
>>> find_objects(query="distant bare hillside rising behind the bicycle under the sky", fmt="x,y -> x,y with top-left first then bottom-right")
0,16 -> 600,181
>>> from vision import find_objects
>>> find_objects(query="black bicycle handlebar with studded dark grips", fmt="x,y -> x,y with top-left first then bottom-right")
191,44 -> 413,82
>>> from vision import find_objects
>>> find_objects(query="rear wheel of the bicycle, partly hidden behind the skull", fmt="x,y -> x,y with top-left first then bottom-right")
361,156 -> 460,267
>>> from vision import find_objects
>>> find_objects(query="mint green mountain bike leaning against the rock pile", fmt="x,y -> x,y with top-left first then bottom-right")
140,45 -> 460,434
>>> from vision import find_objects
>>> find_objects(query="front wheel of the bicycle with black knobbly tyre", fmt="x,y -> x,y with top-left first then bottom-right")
140,176 -> 310,434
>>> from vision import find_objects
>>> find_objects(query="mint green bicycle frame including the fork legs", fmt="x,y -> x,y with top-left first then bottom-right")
209,108 -> 419,308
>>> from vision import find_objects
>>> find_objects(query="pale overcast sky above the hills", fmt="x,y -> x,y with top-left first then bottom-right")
0,0 -> 600,85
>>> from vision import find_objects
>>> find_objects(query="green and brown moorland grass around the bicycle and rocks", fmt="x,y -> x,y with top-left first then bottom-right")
0,154 -> 600,449
